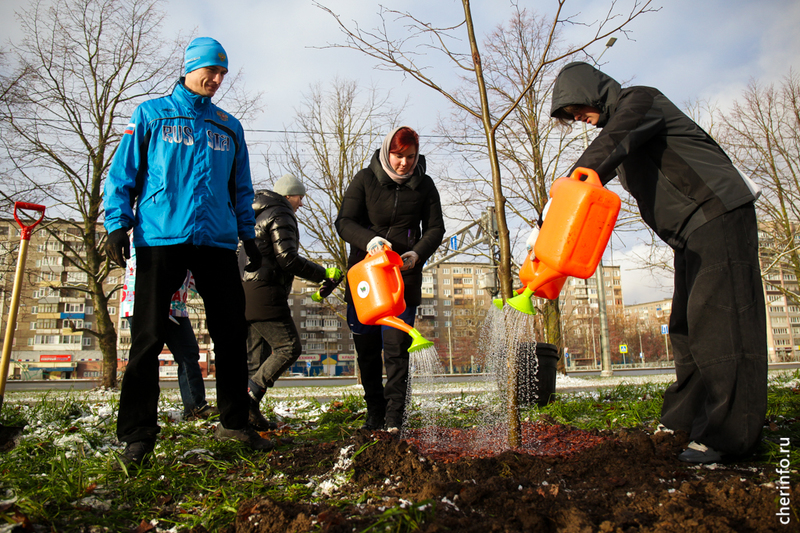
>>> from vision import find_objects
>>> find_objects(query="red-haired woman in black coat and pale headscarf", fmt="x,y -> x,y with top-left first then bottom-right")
335,126 -> 444,431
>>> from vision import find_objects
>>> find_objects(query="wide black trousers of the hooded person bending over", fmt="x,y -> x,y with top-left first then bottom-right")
661,204 -> 767,456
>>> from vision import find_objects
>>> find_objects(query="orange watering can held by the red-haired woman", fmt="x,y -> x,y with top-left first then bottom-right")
347,248 -> 433,352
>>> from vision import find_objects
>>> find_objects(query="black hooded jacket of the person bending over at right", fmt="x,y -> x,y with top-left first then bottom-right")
551,63 -> 757,248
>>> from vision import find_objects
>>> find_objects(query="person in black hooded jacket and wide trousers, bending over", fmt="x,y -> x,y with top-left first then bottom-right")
540,62 -> 767,463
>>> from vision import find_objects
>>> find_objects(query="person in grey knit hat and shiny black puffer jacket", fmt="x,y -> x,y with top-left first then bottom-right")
244,174 -> 342,431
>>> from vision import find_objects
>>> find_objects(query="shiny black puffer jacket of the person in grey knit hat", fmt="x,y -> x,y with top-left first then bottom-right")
239,191 -> 325,322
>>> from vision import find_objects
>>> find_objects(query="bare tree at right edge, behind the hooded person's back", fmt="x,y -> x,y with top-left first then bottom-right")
719,71 -> 800,304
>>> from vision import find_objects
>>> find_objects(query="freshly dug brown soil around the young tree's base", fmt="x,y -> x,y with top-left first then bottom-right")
226,423 -> 800,533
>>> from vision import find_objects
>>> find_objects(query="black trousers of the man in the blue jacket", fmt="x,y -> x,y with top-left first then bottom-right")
117,244 -> 249,443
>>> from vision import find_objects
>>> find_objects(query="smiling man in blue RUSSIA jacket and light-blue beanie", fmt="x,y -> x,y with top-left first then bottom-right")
105,37 -> 273,465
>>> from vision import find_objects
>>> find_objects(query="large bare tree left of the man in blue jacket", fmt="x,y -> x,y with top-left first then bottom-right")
0,0 -> 183,387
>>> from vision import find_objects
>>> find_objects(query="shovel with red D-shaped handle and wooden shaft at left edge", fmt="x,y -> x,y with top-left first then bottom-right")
0,202 -> 44,451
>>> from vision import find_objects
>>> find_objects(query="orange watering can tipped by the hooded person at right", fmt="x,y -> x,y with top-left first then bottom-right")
508,167 -> 622,314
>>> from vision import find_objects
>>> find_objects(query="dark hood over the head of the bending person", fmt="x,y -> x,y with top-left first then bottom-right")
550,62 -> 622,128
